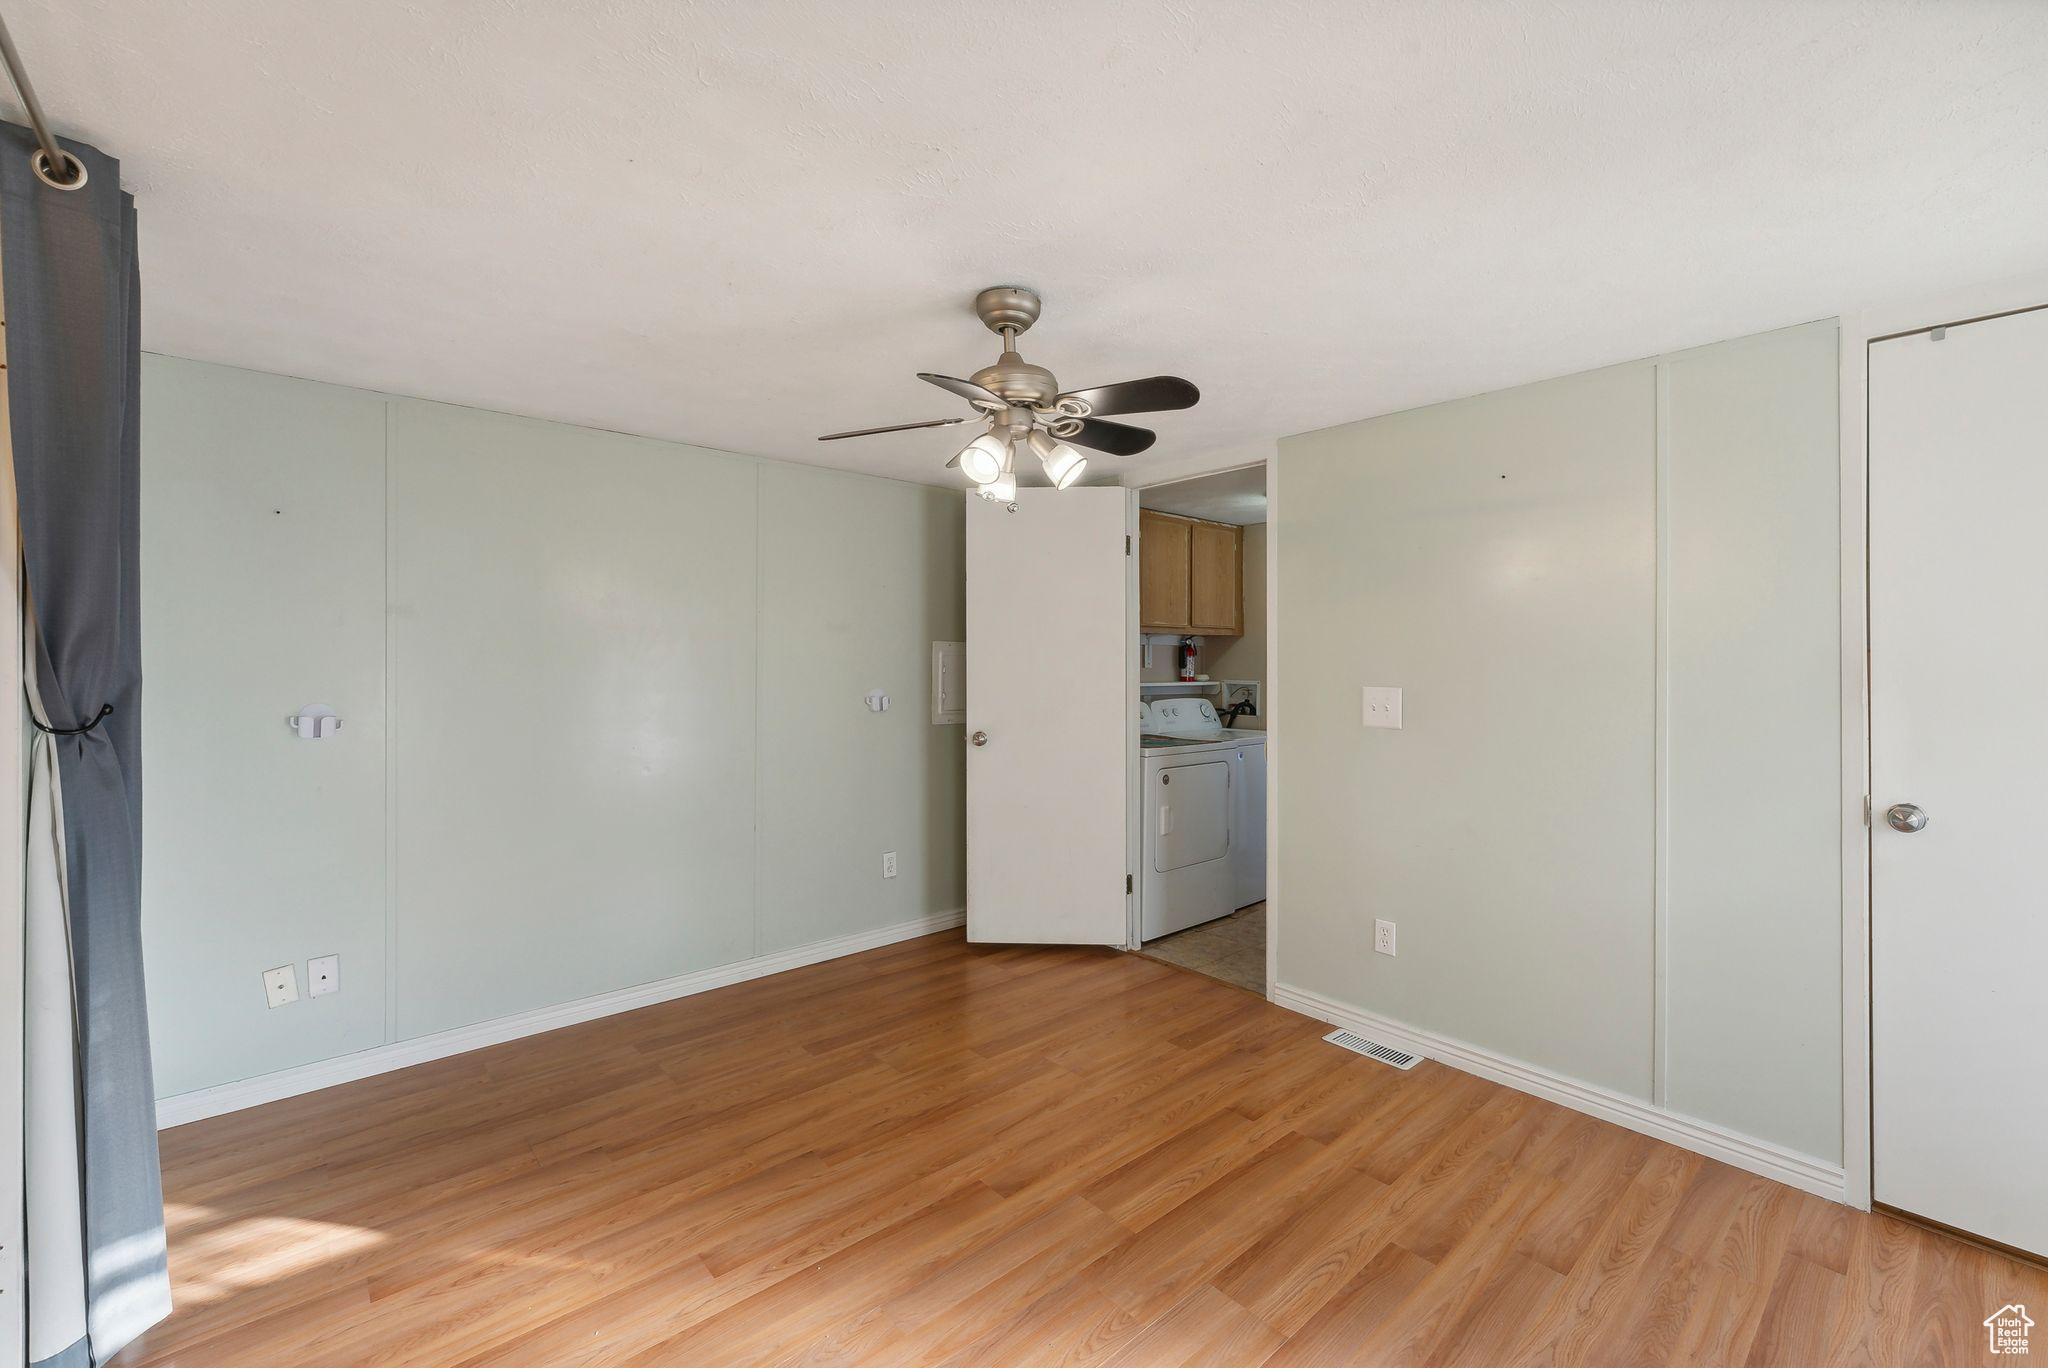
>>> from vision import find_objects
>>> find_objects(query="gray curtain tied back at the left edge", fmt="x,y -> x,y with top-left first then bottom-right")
0,125 -> 170,1368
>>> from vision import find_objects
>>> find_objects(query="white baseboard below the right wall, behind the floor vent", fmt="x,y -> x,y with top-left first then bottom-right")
1270,983 -> 1849,1202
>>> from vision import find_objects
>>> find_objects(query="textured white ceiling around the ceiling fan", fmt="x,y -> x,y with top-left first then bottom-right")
8,0 -> 2048,479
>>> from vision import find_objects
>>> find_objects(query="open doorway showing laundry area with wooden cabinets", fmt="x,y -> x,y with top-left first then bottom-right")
1133,465 -> 1268,995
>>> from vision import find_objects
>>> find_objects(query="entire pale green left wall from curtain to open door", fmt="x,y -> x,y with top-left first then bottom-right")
143,356 -> 965,1096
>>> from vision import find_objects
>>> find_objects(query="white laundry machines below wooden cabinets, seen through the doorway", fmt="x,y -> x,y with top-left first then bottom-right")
1139,698 -> 1266,940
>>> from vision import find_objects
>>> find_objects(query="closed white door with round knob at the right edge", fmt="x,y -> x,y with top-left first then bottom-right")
1870,309 -> 2048,1253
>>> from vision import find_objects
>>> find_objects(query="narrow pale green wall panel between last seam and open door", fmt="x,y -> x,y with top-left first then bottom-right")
756,463 -> 967,954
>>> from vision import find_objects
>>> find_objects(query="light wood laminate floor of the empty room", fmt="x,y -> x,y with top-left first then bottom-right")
119,932 -> 2048,1368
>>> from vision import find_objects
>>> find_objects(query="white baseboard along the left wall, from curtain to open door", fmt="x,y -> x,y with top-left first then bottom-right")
156,909 -> 967,1130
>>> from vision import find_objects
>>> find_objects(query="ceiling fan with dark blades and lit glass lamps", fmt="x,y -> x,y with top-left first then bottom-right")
817,285 -> 1202,504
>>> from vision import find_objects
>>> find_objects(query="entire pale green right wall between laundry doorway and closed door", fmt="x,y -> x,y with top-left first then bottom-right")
1270,324 -> 1841,1163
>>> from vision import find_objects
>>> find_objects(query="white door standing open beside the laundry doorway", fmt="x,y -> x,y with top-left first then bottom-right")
967,489 -> 1137,946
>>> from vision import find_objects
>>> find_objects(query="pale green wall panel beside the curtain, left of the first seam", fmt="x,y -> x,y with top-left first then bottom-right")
141,356 -> 385,1096
